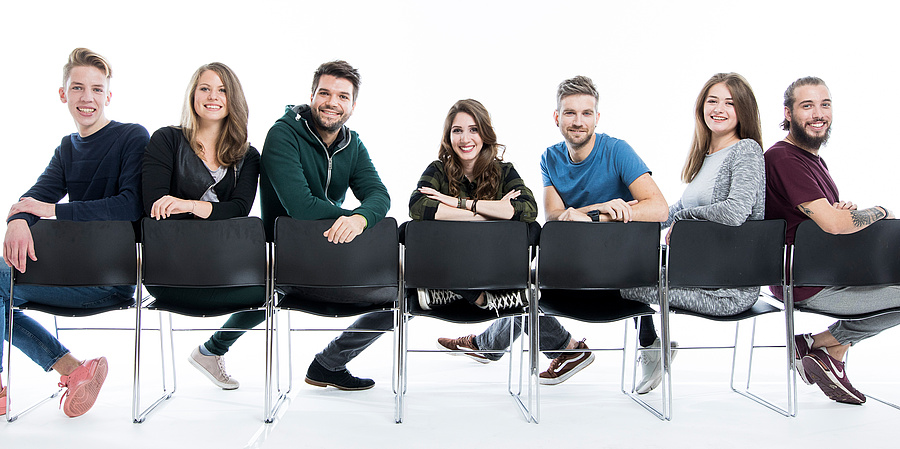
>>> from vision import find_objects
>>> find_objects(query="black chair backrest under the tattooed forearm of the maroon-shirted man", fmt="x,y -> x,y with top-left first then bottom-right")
791,220 -> 900,287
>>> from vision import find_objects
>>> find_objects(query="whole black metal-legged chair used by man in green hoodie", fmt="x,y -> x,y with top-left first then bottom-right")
269,217 -> 400,420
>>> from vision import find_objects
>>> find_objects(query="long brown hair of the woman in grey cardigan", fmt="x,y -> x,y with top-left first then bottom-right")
681,72 -> 762,183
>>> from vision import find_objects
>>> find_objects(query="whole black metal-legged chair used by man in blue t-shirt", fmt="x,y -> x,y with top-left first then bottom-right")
531,221 -> 668,416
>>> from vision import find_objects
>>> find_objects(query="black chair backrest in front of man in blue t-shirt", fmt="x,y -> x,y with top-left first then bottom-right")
537,221 -> 660,290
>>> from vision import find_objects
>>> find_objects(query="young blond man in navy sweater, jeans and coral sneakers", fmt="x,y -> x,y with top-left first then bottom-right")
0,48 -> 150,417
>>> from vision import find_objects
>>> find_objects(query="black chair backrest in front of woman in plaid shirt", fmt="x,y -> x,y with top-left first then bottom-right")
404,221 -> 529,290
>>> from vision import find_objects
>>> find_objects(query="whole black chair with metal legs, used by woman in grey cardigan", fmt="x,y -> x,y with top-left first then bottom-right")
661,220 -> 796,417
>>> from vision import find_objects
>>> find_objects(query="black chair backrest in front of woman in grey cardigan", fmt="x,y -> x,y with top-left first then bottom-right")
666,220 -> 785,288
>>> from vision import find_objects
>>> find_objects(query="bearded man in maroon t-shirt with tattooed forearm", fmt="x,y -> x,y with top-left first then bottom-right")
765,77 -> 900,404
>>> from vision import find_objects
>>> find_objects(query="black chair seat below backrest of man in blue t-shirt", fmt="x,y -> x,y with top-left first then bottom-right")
539,289 -> 656,323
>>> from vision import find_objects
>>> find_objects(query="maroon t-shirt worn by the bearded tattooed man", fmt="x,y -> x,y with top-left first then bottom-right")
765,141 -> 840,301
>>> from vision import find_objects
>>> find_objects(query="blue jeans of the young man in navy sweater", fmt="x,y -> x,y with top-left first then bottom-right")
0,258 -> 134,372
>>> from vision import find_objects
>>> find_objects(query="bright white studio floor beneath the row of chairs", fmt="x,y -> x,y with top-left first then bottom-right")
0,306 -> 900,449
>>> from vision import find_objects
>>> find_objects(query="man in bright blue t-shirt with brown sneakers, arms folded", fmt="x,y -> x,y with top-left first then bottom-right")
438,76 -> 669,384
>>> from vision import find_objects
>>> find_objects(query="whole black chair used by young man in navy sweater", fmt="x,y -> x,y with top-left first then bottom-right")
6,220 -> 140,422
